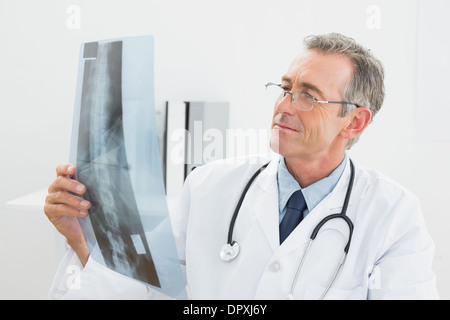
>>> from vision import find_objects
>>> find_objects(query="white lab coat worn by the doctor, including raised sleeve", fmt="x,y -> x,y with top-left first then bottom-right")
50,155 -> 438,299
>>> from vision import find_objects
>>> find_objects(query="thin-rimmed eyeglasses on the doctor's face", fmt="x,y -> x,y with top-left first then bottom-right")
266,82 -> 360,111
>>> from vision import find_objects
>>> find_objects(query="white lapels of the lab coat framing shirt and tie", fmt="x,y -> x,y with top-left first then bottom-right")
253,155 -> 356,259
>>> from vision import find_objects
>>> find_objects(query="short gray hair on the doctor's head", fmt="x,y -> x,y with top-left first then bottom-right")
304,33 -> 385,149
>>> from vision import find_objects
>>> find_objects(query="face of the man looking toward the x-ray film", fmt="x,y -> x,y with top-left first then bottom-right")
270,50 -> 353,159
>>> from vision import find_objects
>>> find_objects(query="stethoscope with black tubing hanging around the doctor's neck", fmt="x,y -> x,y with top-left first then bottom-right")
220,160 -> 355,300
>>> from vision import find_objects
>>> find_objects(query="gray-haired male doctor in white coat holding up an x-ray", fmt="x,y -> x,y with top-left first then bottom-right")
44,34 -> 438,299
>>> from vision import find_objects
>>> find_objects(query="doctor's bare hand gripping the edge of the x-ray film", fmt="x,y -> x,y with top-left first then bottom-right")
44,163 -> 91,265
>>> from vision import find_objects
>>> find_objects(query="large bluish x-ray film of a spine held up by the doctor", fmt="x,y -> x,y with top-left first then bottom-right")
70,36 -> 186,299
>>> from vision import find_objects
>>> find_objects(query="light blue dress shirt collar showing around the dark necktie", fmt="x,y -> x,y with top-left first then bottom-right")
277,154 -> 348,222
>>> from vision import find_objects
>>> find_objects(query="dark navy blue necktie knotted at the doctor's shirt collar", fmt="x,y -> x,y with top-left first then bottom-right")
280,190 -> 306,244
